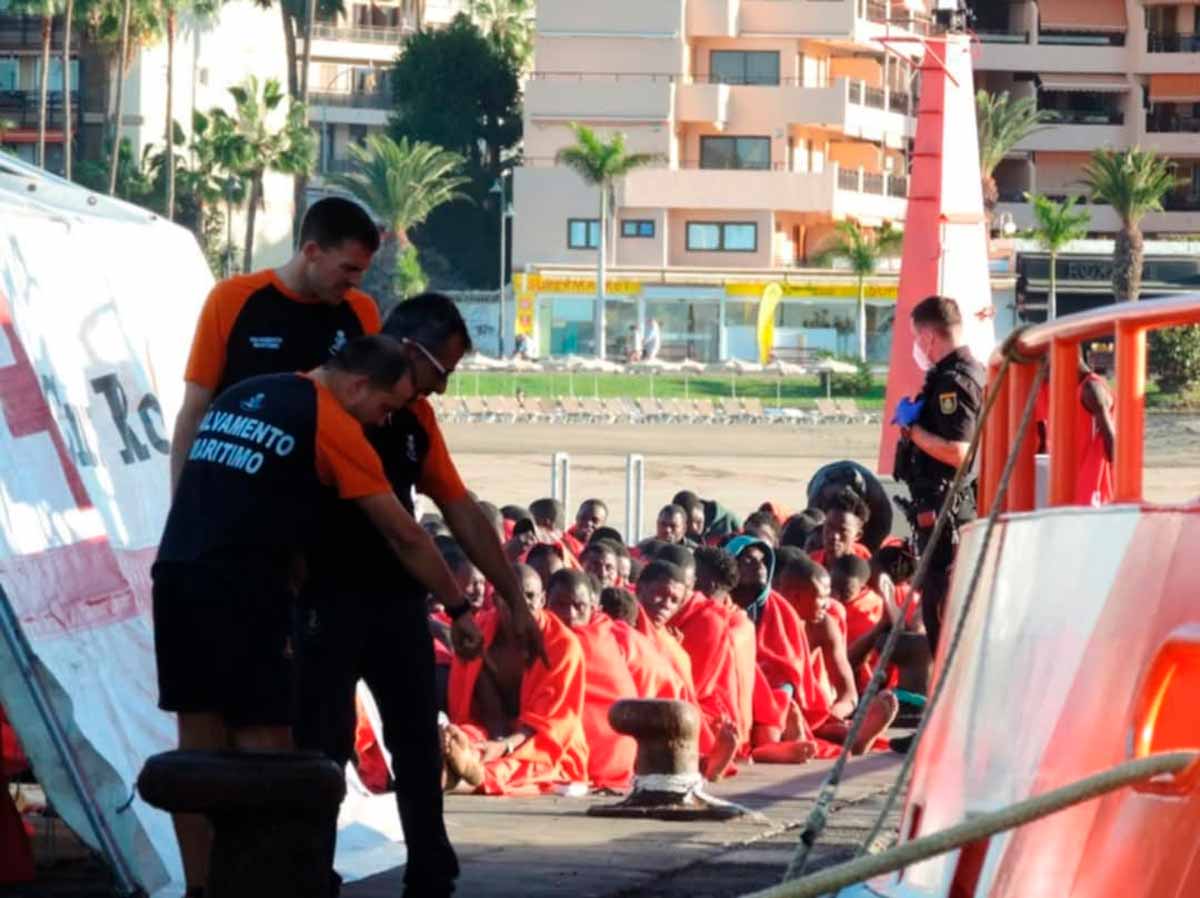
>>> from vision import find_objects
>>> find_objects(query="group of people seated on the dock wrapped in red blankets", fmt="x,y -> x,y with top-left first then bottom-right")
355,486 -> 928,795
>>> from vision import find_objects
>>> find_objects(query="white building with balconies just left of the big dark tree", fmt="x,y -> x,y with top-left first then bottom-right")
308,0 -> 467,188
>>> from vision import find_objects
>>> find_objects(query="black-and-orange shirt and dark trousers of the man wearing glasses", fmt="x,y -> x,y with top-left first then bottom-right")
296,400 -> 468,898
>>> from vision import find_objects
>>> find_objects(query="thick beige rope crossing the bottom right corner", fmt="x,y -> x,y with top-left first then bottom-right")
743,752 -> 1200,898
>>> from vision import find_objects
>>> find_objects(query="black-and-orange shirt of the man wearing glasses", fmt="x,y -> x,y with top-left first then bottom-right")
308,399 -> 468,595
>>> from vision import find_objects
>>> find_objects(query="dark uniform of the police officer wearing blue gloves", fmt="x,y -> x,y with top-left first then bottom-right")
895,347 -> 986,653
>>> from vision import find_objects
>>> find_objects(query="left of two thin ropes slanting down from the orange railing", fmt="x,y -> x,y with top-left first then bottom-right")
784,352 -> 1013,882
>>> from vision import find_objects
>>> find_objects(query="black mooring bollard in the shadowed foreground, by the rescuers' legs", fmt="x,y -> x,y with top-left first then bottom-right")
138,752 -> 346,898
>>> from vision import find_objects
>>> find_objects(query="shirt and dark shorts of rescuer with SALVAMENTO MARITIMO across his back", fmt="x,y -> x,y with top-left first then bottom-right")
150,375 -> 389,726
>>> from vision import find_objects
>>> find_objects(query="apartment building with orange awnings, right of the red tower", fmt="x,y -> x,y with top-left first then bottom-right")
973,0 -> 1200,238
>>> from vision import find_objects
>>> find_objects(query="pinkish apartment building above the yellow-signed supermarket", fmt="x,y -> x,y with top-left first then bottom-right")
512,0 -> 929,361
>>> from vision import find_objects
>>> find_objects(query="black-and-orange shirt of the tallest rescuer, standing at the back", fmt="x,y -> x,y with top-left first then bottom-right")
184,270 -> 379,396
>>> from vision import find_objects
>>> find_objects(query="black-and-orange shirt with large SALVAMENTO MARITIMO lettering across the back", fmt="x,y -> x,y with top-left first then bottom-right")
158,375 -> 391,576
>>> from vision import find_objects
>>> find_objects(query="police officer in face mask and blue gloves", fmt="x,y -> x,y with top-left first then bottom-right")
894,297 -> 986,654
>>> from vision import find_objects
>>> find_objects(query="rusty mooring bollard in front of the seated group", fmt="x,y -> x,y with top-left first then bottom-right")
588,699 -> 752,820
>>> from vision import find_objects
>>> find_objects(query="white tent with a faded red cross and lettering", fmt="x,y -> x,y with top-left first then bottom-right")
0,156 -> 403,894
